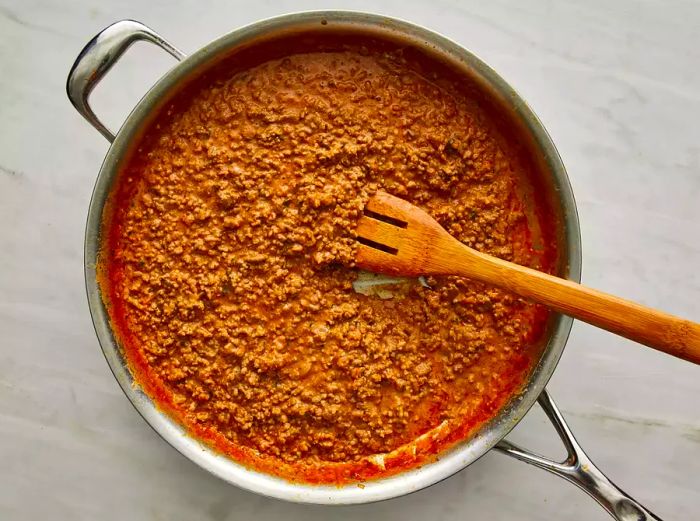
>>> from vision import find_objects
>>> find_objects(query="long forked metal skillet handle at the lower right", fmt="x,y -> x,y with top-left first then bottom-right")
494,390 -> 661,521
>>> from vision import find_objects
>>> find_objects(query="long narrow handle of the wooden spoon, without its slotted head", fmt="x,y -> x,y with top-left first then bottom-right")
453,244 -> 700,364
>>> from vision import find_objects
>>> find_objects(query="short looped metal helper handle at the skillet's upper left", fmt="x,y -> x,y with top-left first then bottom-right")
66,20 -> 185,143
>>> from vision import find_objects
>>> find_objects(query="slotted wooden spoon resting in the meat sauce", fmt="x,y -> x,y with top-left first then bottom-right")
355,192 -> 700,364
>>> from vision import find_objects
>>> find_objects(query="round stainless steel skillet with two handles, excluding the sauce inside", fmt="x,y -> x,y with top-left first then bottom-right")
67,11 -> 658,520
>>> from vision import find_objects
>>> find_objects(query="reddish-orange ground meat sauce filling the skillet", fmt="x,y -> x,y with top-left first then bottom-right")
100,29 -> 556,484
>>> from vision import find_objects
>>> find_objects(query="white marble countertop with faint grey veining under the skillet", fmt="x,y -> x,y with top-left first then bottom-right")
0,0 -> 700,521
